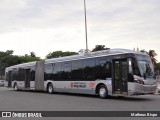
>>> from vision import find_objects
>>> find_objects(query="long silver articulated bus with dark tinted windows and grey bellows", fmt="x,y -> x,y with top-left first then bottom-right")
5,49 -> 157,98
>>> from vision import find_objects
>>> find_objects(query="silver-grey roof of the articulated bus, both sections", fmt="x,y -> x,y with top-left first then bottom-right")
6,49 -> 147,70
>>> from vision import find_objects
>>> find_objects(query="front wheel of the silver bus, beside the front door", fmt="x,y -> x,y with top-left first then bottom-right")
98,85 -> 108,99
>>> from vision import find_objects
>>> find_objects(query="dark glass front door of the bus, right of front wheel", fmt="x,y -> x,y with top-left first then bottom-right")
112,59 -> 128,95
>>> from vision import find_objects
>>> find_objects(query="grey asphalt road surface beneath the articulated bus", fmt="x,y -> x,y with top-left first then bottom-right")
0,87 -> 160,120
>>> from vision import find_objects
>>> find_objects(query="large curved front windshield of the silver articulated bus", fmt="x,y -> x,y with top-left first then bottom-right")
138,55 -> 154,78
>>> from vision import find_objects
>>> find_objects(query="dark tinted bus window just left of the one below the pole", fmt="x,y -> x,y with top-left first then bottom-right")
72,60 -> 83,80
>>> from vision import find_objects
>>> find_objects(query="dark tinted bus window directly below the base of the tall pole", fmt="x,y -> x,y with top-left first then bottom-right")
83,59 -> 95,80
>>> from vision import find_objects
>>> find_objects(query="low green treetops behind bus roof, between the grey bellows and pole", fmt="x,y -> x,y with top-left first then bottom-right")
46,51 -> 78,59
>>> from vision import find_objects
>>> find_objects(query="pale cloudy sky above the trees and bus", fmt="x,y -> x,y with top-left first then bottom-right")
0,0 -> 160,62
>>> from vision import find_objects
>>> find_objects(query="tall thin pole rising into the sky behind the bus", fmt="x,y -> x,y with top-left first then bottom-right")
84,0 -> 88,53
